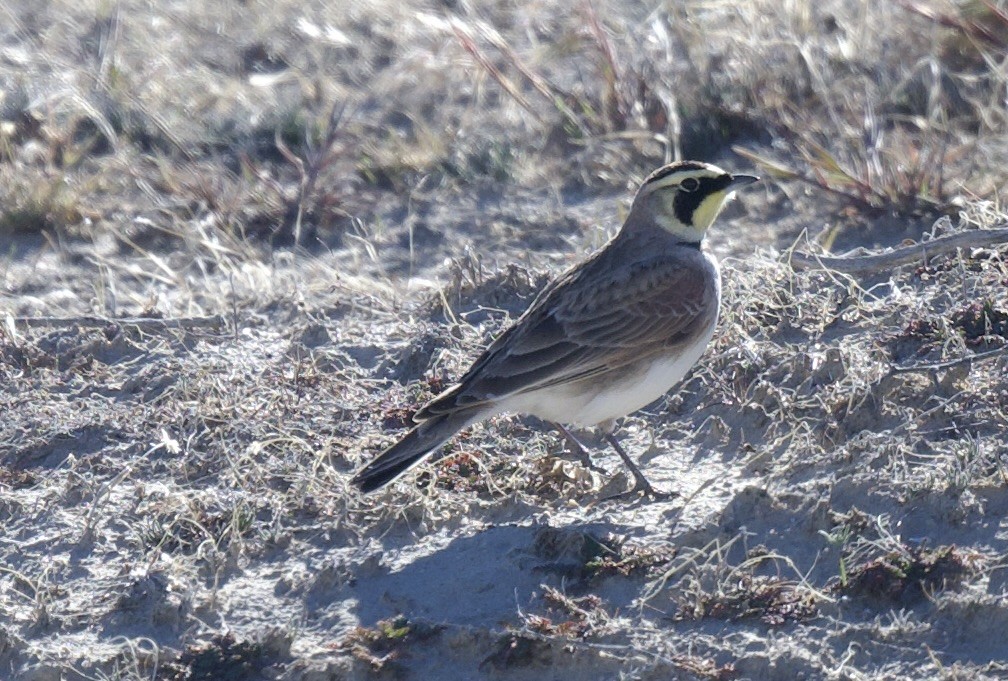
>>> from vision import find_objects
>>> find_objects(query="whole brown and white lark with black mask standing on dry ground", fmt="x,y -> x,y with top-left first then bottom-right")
353,161 -> 758,496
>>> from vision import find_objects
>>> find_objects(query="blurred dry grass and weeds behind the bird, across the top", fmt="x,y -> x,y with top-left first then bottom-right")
0,0 -> 1008,288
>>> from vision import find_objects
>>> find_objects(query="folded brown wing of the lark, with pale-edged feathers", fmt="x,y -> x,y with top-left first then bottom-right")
414,254 -> 717,420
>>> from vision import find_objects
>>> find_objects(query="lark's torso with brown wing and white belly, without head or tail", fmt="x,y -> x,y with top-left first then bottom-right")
417,230 -> 720,425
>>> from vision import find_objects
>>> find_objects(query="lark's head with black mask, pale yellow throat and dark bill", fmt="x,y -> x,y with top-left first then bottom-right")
627,161 -> 759,244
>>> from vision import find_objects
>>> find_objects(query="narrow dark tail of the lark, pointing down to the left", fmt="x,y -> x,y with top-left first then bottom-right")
352,410 -> 483,493
